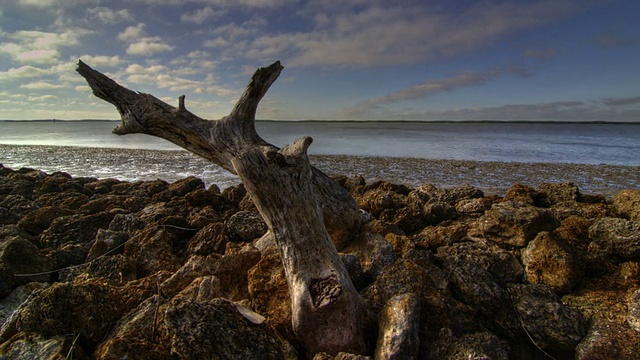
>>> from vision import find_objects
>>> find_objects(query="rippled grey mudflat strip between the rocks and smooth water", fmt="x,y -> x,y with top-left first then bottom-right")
0,145 -> 640,197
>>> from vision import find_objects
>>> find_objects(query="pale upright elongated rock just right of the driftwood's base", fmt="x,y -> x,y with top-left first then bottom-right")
375,293 -> 420,360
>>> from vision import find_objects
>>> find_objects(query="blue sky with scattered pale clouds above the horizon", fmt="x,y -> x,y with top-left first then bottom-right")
0,0 -> 640,122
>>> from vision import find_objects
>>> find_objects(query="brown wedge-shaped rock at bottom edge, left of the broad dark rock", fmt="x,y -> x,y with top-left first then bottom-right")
93,295 -> 174,360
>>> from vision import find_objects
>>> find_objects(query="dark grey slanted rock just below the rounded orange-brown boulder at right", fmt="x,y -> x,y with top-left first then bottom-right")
508,284 -> 587,352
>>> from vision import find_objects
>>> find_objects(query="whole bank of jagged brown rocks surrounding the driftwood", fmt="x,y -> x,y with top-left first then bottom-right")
0,166 -> 640,359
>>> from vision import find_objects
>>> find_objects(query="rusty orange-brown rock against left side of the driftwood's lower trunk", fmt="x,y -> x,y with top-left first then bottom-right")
247,245 -> 292,334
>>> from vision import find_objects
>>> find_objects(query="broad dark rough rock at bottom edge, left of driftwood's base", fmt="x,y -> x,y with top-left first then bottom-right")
165,299 -> 291,360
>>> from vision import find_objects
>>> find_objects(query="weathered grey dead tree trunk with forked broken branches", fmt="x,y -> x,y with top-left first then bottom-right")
77,61 -> 365,354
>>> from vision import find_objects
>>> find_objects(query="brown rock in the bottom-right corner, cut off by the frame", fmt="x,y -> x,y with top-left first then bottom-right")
575,318 -> 640,360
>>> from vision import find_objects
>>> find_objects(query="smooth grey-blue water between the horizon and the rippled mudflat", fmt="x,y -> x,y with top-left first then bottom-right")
0,121 -> 640,166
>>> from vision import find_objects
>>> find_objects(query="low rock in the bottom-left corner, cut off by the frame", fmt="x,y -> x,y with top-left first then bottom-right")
0,333 -> 89,360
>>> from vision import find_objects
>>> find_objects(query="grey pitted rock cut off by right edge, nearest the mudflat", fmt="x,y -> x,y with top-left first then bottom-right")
589,218 -> 640,259
